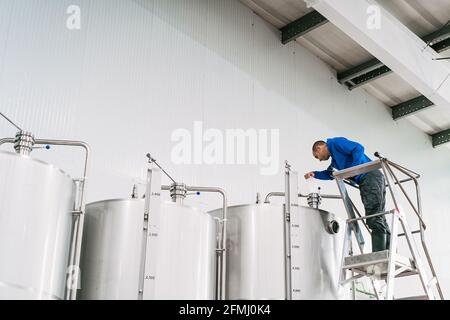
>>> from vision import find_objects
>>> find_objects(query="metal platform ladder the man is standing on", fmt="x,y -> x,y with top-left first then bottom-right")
333,153 -> 444,300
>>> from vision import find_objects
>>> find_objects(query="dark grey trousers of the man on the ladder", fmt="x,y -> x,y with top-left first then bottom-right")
359,170 -> 391,237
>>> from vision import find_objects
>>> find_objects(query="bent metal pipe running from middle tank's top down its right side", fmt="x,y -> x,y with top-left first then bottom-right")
161,185 -> 228,300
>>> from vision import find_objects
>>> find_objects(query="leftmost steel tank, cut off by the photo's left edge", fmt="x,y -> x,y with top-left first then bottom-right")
0,152 -> 75,300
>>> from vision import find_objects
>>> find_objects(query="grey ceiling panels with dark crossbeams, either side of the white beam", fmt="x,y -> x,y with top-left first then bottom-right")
241,0 -> 450,148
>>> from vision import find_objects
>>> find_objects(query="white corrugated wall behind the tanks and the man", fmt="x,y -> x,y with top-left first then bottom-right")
0,0 -> 450,298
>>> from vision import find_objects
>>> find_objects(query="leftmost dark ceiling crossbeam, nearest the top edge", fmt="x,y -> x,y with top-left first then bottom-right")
280,10 -> 328,44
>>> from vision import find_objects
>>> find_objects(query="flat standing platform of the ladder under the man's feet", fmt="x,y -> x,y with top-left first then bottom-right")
343,250 -> 417,277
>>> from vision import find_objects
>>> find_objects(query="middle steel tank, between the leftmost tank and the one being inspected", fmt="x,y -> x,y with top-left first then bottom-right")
80,199 -> 216,300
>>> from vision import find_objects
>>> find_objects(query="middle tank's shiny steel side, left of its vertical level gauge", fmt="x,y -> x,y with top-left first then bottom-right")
79,199 -> 144,299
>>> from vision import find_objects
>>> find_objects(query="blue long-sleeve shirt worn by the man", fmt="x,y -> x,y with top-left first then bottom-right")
314,137 -> 372,183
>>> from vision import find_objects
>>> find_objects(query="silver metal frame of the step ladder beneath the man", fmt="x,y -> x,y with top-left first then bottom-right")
335,158 -> 444,300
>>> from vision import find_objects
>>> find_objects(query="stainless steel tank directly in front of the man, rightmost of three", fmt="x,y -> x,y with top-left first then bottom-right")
210,204 -> 348,300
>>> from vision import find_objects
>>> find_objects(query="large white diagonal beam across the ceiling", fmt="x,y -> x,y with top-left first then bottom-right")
306,0 -> 450,108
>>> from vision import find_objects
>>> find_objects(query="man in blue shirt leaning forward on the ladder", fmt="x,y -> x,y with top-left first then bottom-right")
305,137 -> 390,252
